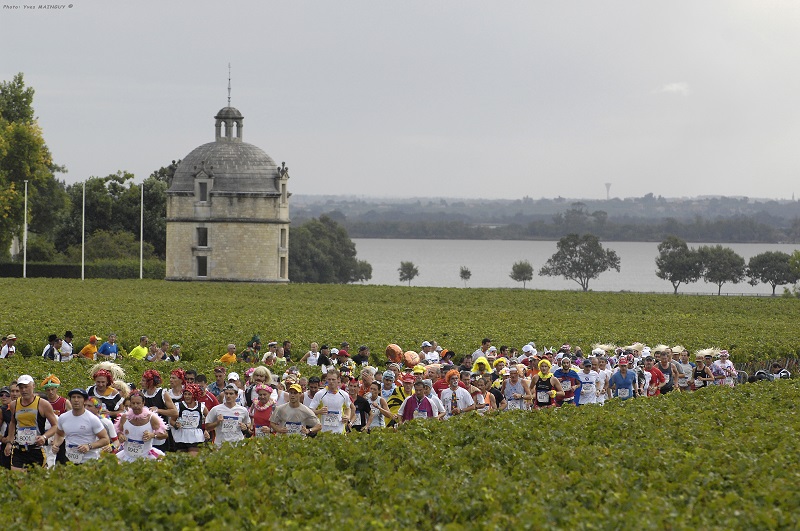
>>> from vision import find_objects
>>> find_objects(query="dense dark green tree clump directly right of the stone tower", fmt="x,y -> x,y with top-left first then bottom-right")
289,216 -> 372,284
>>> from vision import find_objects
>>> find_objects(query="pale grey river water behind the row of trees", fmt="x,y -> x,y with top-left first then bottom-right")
353,238 -> 800,295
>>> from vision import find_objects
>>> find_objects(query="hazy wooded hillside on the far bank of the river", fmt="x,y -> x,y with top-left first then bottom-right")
292,194 -> 800,243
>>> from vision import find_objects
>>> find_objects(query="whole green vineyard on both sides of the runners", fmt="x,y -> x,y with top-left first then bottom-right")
0,279 -> 800,529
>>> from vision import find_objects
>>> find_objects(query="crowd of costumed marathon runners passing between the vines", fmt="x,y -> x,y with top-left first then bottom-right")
0,334 -> 789,470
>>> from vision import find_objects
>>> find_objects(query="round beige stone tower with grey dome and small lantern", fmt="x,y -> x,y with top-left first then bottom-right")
166,107 -> 290,282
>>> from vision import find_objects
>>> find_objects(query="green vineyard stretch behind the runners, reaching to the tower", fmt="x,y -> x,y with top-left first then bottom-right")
0,279 -> 800,365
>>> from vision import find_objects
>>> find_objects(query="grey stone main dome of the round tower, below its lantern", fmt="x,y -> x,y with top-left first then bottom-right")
169,141 -> 280,195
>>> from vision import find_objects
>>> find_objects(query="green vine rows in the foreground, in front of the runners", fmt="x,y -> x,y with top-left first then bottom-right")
0,380 -> 800,529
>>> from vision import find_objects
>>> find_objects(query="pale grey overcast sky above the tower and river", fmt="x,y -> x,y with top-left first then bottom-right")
0,0 -> 800,198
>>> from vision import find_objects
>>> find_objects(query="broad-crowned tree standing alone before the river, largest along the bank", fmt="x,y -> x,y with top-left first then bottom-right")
539,234 -> 620,291
